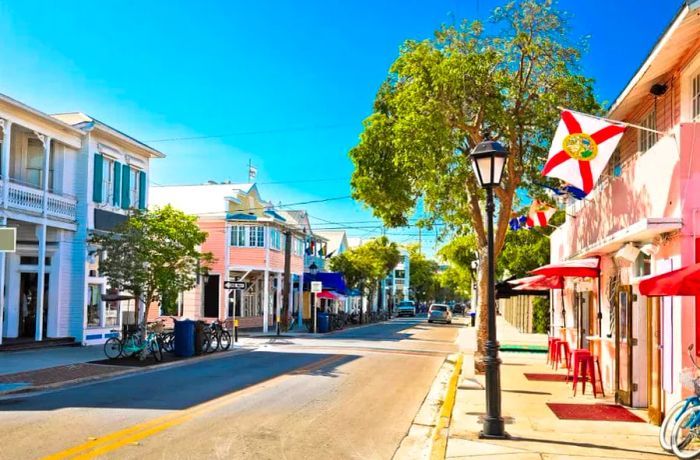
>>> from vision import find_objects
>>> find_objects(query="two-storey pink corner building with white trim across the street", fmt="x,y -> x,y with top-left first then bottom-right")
150,184 -> 310,331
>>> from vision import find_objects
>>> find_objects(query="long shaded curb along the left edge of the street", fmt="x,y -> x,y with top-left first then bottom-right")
0,347 -> 253,400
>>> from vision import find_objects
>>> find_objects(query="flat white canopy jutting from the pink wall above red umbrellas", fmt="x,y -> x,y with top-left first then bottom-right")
571,217 -> 683,259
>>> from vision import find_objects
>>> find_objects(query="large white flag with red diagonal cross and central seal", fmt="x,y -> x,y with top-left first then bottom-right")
542,110 -> 625,194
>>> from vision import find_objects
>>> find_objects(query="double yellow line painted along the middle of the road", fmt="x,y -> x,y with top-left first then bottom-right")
44,355 -> 347,460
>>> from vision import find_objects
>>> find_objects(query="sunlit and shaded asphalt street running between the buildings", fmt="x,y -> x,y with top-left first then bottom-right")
0,318 -> 458,460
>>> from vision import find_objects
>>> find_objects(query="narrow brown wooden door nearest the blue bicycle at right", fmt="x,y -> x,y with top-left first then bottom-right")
647,297 -> 663,425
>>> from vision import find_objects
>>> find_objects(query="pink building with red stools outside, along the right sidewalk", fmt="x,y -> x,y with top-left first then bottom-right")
551,2 -> 700,423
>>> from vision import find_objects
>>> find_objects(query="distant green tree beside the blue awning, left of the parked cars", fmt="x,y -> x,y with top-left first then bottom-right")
330,236 -> 401,322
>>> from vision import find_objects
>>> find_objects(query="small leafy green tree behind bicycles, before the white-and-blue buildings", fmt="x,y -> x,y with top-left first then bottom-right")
90,205 -> 212,333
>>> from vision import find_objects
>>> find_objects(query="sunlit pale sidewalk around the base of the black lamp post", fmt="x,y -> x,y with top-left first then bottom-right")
446,317 -> 669,460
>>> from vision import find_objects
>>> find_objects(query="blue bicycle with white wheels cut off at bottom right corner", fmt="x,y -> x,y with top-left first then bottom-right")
659,344 -> 700,459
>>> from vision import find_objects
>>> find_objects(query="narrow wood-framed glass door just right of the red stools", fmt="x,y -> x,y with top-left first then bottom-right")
615,286 -> 634,406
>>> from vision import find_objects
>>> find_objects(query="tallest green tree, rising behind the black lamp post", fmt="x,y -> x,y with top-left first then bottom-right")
350,0 -> 598,368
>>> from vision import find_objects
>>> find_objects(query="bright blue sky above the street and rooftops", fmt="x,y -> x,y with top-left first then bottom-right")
0,0 -> 681,256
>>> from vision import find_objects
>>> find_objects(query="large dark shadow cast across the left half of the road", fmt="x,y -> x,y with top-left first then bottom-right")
0,351 -> 359,414
